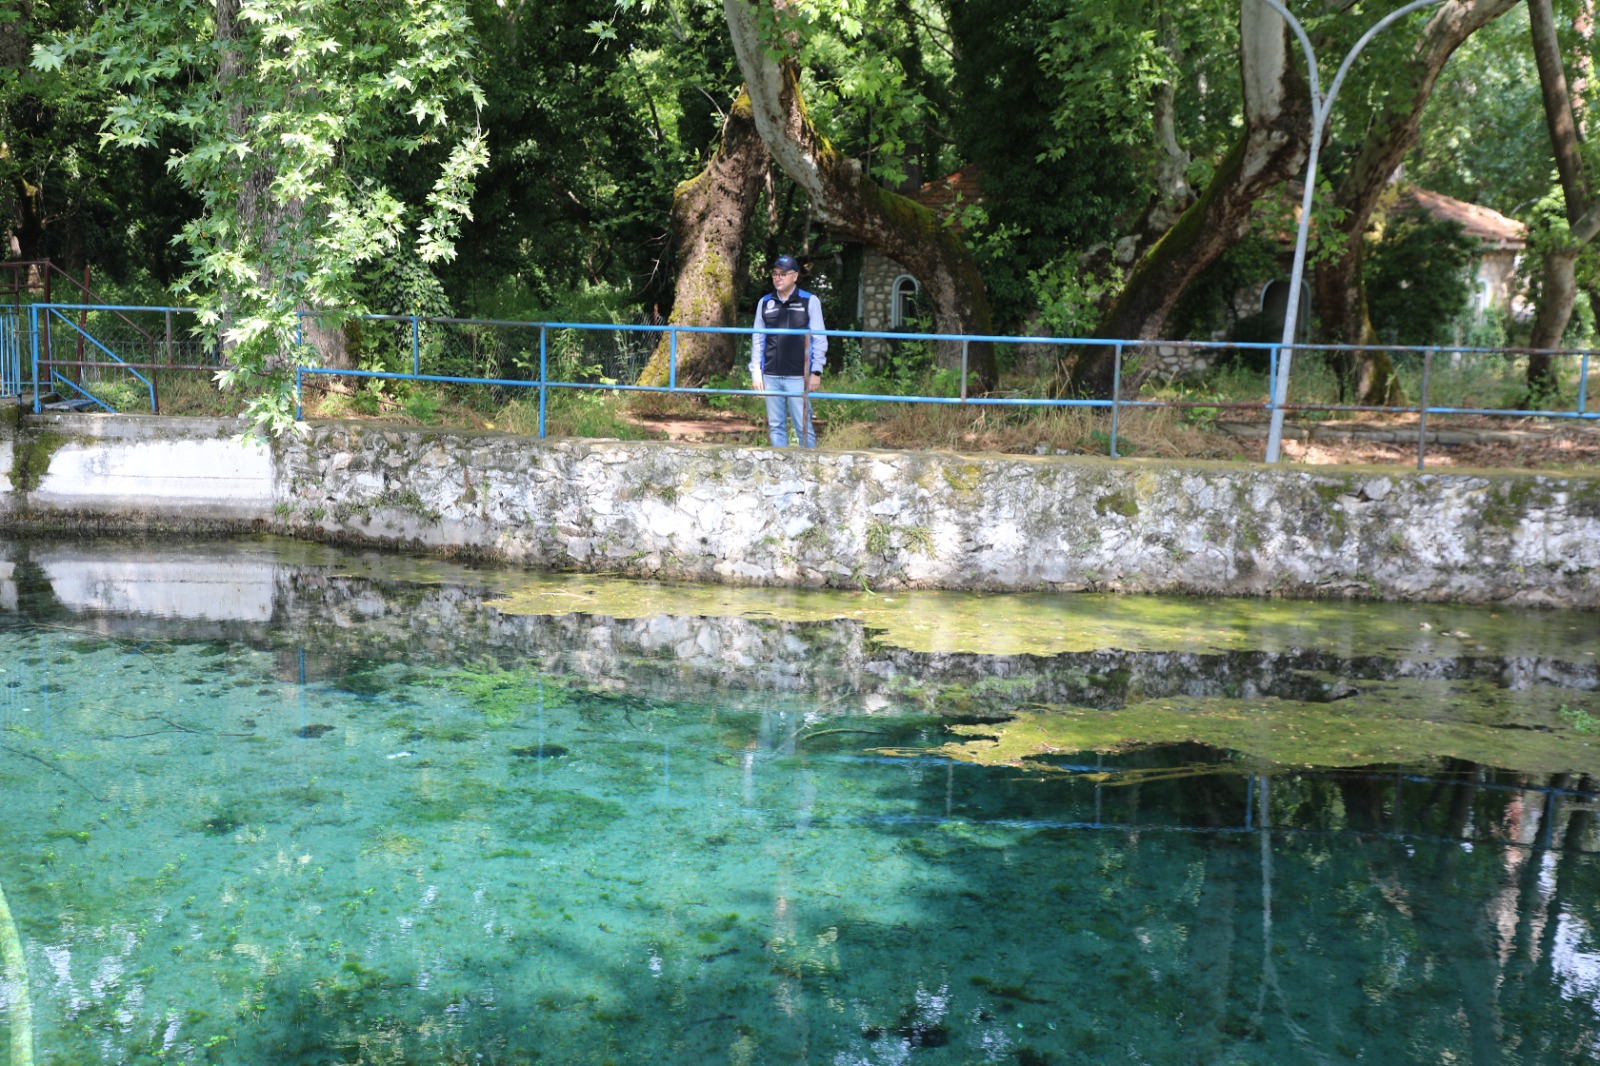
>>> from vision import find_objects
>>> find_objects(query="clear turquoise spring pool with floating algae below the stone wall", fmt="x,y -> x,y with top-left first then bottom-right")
0,541 -> 1600,1066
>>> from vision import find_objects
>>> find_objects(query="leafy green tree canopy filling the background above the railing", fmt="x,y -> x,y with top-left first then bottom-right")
9,0 -> 1595,423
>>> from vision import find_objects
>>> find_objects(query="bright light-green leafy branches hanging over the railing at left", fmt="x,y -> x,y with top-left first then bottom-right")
34,0 -> 485,431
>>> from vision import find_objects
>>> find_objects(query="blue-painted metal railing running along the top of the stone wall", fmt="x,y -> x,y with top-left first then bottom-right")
12,304 -> 1600,467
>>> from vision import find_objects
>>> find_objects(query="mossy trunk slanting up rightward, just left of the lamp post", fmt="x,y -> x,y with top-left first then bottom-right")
1053,0 -> 1310,399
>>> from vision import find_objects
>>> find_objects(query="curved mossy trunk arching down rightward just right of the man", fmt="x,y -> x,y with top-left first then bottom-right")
723,0 -> 995,387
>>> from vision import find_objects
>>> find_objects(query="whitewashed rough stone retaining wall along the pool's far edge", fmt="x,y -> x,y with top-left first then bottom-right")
0,415 -> 1600,608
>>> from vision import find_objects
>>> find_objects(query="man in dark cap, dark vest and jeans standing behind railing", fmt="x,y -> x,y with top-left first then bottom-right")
750,256 -> 827,448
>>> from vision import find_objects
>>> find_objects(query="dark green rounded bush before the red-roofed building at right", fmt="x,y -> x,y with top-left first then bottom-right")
1365,210 -> 1477,346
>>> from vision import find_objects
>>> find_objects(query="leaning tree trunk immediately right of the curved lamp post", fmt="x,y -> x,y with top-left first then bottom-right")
1312,0 -> 1518,407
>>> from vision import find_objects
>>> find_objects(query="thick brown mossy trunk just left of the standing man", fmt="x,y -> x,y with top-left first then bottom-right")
638,93 -> 770,386
